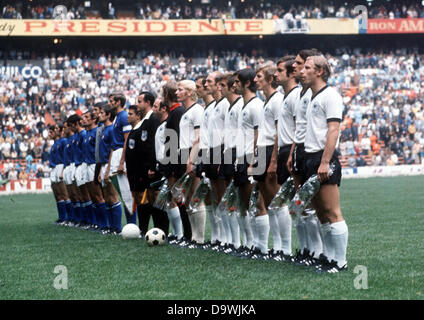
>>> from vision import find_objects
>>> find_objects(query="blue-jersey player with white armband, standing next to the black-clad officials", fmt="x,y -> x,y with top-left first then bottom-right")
105,93 -> 137,233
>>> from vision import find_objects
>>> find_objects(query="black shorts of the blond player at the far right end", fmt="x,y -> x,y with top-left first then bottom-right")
305,150 -> 342,187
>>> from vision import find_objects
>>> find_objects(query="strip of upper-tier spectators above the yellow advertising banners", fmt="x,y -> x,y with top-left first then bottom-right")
0,0 -> 424,19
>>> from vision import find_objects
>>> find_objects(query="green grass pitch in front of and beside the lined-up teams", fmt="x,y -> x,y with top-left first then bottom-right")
0,176 -> 424,300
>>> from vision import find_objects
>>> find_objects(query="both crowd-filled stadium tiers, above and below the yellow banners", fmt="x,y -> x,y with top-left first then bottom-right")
0,0 -> 424,180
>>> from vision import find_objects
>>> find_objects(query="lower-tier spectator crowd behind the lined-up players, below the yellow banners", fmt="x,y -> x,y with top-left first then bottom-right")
0,46 -> 424,177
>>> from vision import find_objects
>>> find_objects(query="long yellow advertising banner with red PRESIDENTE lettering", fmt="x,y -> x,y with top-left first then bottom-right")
0,19 -> 274,37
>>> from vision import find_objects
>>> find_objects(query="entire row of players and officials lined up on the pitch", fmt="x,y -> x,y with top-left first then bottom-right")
48,50 -> 348,273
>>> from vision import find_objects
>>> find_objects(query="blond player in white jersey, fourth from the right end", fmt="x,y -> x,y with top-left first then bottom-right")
255,63 -> 291,261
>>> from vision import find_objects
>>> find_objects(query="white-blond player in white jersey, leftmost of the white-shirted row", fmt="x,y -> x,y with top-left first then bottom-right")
176,80 -> 206,247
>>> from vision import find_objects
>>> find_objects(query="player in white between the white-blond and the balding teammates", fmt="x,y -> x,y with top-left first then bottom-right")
196,76 -> 219,249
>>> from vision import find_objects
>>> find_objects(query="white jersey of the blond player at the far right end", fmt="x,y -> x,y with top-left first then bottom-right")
305,86 -> 343,153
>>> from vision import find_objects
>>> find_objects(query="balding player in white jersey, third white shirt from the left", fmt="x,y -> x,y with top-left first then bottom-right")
205,71 -> 230,251
